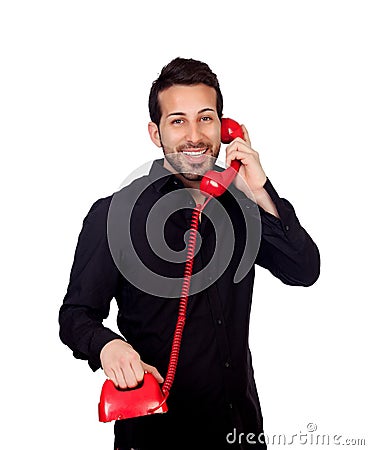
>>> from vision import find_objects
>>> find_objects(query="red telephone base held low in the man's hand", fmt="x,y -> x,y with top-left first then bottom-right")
99,372 -> 168,422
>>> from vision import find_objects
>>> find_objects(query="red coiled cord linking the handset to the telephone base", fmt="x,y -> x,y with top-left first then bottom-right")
150,197 -> 211,412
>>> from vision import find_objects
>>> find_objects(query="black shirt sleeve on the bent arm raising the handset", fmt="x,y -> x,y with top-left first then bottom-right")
256,179 -> 320,286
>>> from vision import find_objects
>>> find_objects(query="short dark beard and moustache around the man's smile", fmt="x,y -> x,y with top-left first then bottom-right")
163,142 -> 220,181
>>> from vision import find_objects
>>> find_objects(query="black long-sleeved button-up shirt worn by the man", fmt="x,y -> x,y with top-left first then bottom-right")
59,160 -> 320,449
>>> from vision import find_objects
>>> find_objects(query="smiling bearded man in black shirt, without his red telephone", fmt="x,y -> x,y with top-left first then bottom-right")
59,58 -> 320,450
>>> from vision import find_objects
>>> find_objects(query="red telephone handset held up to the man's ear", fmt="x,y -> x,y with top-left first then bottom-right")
200,118 -> 244,197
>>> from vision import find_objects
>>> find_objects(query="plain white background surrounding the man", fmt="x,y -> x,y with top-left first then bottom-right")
0,0 -> 369,450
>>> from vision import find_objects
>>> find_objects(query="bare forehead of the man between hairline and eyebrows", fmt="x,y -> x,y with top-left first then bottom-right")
158,84 -> 217,115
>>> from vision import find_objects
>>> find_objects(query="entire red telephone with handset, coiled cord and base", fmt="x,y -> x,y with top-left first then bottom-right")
98,118 -> 243,422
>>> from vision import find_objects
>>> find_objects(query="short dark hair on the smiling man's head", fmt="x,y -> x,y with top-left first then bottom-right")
149,58 -> 223,126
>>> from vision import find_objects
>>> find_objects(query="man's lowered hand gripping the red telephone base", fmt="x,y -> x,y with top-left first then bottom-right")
100,339 -> 164,389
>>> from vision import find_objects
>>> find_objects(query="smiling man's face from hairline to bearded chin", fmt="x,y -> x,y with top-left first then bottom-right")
151,84 -> 220,181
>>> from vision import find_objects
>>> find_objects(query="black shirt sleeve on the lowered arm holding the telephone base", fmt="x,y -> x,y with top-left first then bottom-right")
59,197 -> 123,370
